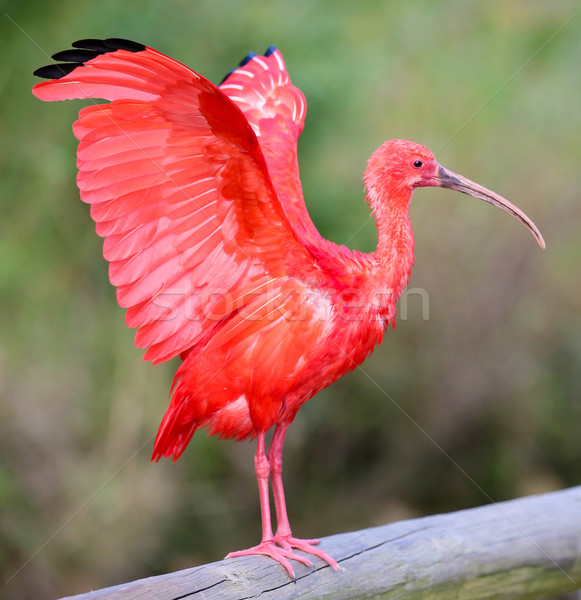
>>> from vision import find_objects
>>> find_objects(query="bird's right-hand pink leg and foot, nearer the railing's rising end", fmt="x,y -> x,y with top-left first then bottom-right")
267,425 -> 340,571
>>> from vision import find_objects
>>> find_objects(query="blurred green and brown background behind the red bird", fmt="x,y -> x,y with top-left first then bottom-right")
0,0 -> 581,599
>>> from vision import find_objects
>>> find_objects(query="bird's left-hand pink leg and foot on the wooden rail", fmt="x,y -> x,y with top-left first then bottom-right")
226,431 -> 311,579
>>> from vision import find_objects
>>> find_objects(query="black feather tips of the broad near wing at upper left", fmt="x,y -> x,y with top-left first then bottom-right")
33,38 -> 146,79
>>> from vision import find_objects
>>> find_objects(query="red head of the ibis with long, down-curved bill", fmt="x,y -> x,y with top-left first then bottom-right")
364,140 -> 545,248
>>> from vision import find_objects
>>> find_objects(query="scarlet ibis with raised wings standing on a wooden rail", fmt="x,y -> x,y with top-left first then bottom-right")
33,38 -> 544,576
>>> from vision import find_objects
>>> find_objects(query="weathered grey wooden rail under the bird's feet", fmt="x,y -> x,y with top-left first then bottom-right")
61,486 -> 581,600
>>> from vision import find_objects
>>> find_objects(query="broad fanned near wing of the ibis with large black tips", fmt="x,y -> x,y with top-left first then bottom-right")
33,39 -> 316,362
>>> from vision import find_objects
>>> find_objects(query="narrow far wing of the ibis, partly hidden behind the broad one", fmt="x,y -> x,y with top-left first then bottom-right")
220,46 -> 322,244
